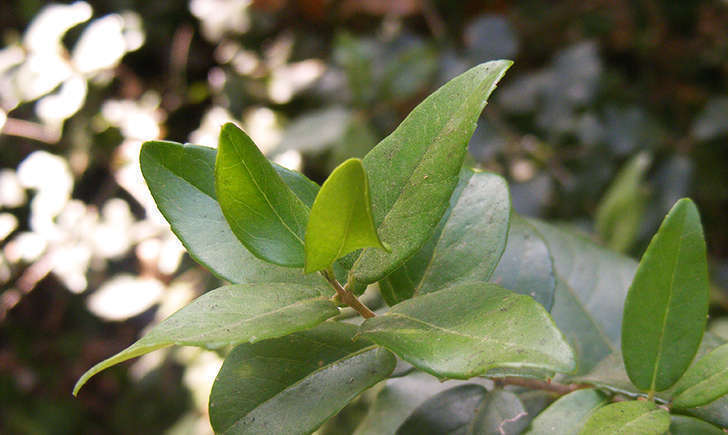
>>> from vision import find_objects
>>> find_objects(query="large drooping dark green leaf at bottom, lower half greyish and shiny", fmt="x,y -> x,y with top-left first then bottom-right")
210,322 -> 396,434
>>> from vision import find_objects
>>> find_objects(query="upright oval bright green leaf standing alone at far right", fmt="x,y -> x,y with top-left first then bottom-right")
622,199 -> 708,392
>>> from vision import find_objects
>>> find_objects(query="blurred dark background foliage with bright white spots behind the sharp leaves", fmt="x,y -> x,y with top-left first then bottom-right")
0,0 -> 728,433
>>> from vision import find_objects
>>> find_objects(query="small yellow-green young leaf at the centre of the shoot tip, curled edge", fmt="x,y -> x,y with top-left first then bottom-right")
304,159 -> 387,273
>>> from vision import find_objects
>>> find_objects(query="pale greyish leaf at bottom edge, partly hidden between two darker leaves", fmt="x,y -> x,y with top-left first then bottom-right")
354,371 -> 486,435
